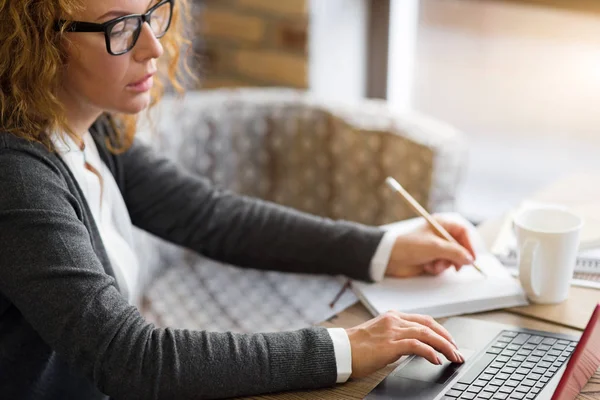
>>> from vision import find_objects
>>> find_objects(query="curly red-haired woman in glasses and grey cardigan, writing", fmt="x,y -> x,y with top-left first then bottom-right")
0,0 -> 474,399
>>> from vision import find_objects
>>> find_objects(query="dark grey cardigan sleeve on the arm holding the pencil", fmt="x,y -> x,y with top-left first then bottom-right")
120,142 -> 383,281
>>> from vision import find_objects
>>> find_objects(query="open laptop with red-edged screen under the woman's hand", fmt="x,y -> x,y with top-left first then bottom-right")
366,304 -> 600,400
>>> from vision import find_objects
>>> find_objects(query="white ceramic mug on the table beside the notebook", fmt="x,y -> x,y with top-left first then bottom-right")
514,208 -> 583,304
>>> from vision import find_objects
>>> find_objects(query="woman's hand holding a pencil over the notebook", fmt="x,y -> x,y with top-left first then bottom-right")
385,217 -> 475,278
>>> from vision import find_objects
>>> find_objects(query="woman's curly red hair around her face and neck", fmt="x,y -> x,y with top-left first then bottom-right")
0,0 -> 192,152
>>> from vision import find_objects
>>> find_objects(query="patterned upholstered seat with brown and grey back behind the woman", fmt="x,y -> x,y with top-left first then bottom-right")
139,89 -> 466,331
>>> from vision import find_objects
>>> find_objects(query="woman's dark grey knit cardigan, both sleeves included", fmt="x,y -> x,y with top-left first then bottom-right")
0,117 -> 383,400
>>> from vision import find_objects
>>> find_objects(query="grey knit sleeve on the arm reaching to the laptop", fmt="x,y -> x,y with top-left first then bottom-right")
0,149 -> 336,399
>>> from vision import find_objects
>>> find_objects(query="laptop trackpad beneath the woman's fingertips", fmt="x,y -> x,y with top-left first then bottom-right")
394,349 -> 474,385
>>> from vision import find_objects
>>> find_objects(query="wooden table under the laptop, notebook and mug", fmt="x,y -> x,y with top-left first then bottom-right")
241,175 -> 600,400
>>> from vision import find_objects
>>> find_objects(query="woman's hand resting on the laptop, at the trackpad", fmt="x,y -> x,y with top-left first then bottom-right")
346,311 -> 465,378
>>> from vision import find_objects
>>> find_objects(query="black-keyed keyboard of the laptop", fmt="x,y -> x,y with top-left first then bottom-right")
444,331 -> 577,400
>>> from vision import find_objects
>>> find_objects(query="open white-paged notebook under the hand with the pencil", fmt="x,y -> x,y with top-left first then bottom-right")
352,214 -> 528,318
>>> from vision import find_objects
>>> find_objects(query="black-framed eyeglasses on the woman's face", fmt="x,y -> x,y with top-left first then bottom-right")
55,0 -> 175,56
